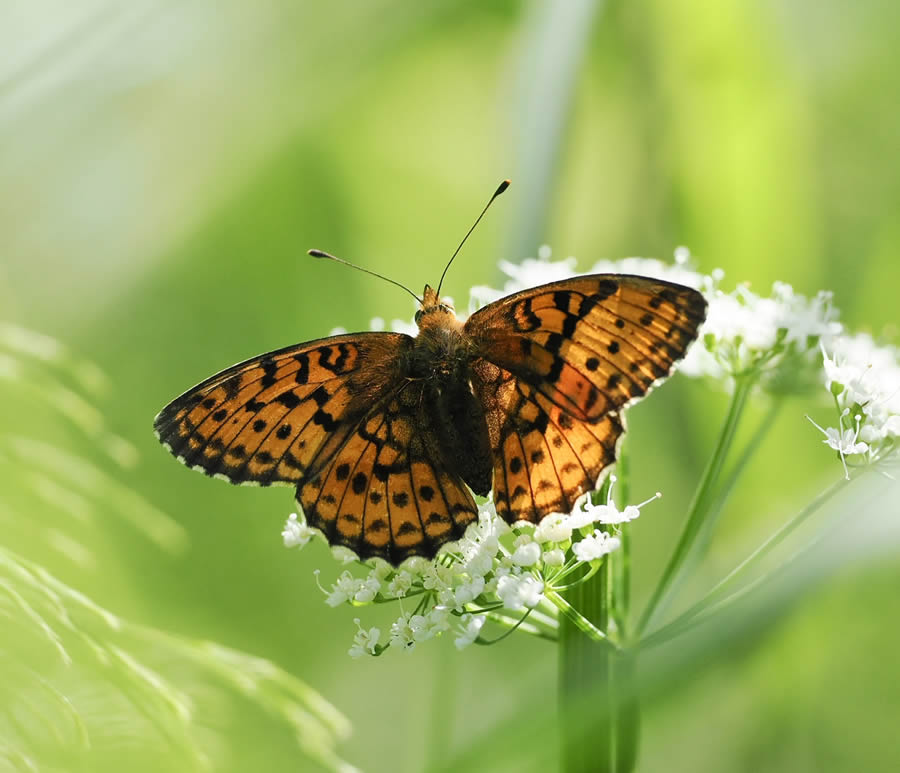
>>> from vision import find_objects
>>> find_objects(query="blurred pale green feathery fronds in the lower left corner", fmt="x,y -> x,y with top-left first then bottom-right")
0,324 -> 355,772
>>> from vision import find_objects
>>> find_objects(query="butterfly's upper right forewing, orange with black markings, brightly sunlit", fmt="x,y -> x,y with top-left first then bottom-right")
465,274 -> 706,420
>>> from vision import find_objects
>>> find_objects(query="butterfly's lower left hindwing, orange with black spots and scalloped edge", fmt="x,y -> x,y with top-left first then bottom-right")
297,380 -> 477,565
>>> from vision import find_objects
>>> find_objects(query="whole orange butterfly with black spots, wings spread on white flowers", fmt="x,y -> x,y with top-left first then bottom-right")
154,184 -> 706,565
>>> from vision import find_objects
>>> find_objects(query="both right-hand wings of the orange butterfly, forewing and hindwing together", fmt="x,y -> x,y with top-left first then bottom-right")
464,274 -> 706,521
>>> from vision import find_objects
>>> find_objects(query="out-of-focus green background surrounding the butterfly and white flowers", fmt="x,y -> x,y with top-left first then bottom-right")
0,0 -> 900,771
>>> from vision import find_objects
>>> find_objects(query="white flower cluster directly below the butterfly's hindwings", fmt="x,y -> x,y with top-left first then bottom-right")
282,478 -> 660,657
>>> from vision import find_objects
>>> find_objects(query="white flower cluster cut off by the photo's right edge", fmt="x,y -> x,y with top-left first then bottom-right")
810,333 -> 900,479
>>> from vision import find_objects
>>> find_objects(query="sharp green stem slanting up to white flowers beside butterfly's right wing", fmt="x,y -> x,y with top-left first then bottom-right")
636,372 -> 756,637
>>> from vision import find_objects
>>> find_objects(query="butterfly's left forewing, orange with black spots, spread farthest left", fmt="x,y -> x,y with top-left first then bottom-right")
154,333 -> 413,485
